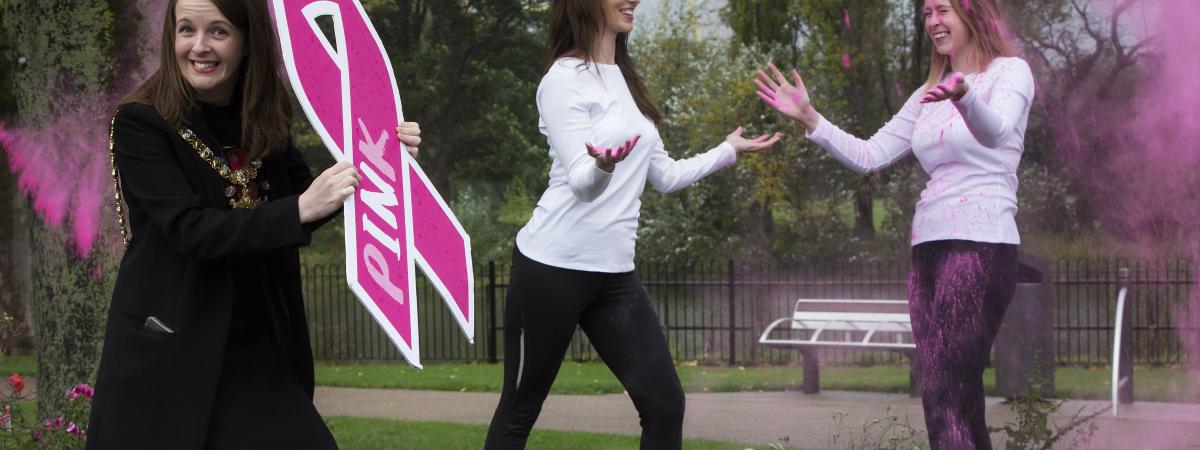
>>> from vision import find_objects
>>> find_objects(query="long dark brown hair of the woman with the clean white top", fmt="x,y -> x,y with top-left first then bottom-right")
545,0 -> 662,125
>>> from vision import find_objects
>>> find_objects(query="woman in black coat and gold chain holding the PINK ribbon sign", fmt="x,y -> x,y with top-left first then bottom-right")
88,0 -> 420,449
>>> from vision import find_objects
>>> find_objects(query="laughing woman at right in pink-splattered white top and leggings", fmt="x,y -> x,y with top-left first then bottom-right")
756,0 -> 1034,449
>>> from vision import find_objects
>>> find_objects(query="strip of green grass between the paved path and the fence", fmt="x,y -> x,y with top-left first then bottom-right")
0,356 -> 1200,402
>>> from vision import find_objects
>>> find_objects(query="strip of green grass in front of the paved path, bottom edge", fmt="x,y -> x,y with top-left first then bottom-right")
326,418 -> 746,450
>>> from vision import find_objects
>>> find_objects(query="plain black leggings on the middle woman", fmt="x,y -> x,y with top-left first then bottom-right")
484,251 -> 684,449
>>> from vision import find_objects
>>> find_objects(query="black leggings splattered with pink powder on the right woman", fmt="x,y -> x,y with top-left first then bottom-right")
908,240 -> 1016,450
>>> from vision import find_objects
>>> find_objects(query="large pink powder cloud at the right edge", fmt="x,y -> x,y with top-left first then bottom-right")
1046,0 -> 1200,398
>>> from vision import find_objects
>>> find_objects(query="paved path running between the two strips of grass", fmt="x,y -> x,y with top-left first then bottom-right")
317,388 -> 1200,450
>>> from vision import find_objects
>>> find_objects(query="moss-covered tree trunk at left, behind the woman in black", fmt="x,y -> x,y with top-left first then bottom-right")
5,0 -> 120,416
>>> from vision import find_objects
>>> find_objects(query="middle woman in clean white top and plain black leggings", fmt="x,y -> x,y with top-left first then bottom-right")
485,0 -> 779,449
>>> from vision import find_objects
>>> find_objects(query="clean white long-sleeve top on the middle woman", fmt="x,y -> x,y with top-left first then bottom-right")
517,58 -> 737,274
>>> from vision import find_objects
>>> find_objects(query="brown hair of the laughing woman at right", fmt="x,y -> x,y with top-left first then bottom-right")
925,0 -> 1016,88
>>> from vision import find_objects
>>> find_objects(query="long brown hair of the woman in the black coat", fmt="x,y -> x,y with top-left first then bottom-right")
120,0 -> 292,160
